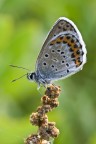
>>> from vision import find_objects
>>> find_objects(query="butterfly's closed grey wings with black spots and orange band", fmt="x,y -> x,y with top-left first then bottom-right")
36,18 -> 86,81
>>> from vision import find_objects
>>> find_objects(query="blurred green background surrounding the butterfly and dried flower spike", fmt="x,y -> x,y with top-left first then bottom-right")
0,0 -> 96,144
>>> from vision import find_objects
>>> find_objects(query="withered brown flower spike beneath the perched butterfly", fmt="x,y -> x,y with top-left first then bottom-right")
25,85 -> 61,144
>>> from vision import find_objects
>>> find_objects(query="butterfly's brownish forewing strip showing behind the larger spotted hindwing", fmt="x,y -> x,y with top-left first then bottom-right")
37,17 -> 78,63
